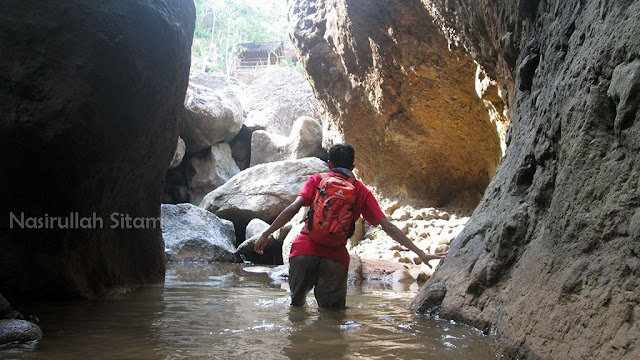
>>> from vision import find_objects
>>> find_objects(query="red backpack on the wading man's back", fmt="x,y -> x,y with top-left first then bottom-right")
301,173 -> 356,247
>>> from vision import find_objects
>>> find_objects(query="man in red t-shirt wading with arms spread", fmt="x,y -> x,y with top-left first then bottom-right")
254,144 -> 446,308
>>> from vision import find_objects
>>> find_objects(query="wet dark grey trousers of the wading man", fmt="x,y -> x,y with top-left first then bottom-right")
289,255 -> 347,308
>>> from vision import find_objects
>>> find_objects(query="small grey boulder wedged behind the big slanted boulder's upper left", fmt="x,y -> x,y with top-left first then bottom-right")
186,143 -> 240,205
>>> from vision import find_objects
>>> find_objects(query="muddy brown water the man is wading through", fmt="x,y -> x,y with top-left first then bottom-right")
0,264 -> 494,360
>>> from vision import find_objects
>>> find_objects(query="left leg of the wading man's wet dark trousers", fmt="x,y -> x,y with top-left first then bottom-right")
289,255 -> 322,306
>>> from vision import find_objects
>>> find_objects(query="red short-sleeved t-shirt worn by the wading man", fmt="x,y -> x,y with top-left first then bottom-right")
289,173 -> 385,268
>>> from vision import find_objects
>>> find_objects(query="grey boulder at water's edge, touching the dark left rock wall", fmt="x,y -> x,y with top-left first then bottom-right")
162,204 -> 236,262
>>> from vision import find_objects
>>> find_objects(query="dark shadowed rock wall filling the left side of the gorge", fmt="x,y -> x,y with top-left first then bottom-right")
0,0 -> 195,301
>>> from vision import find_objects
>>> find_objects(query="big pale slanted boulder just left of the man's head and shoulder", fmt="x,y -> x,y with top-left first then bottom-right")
200,158 -> 329,239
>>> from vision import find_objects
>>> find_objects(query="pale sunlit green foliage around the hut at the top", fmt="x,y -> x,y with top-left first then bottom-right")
191,0 -> 287,73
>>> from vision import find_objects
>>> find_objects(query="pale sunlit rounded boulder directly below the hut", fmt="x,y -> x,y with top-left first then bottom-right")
242,67 -> 321,136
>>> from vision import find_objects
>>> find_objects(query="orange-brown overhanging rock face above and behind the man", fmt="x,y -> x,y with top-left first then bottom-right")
289,0 -> 501,209
